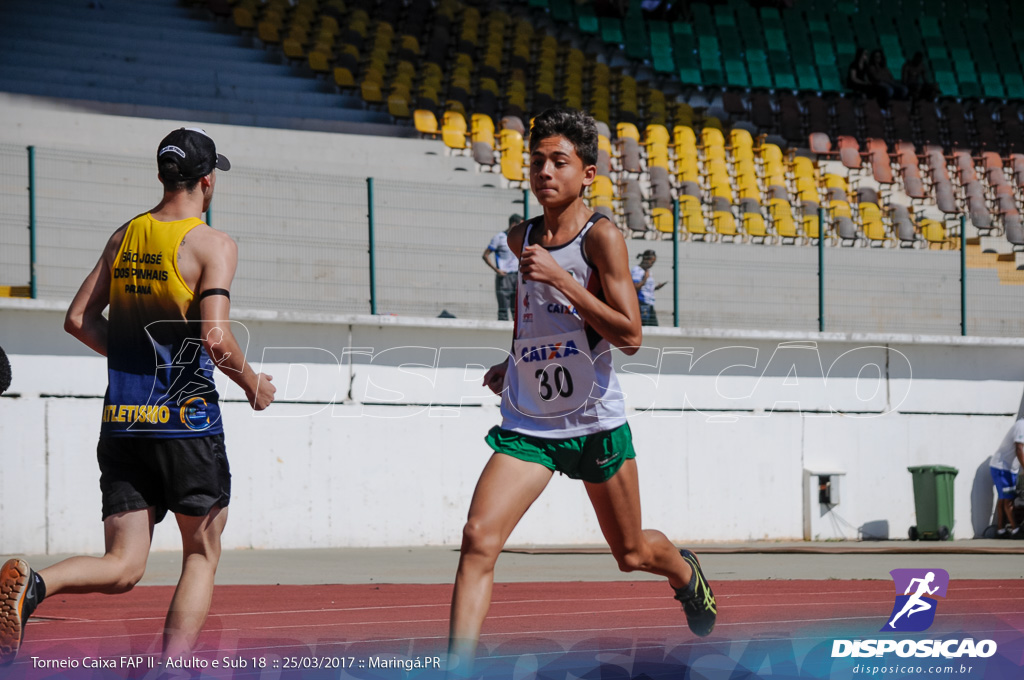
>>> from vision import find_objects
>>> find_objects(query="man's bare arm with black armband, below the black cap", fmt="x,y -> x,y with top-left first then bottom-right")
196,227 -> 278,411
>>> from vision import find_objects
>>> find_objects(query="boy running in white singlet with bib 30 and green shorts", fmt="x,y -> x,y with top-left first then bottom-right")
449,110 -> 717,676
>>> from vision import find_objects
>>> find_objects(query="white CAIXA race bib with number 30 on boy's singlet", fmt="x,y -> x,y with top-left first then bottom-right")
513,331 -> 597,418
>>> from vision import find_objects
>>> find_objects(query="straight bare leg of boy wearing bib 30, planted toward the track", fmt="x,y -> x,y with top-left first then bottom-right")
449,454 -> 553,672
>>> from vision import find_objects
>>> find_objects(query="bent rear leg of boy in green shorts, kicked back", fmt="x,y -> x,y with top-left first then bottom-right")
585,459 -> 693,589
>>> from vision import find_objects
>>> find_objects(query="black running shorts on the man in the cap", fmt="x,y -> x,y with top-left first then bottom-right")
96,434 -> 231,522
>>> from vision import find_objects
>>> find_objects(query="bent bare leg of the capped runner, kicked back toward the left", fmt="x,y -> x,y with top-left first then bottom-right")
39,508 -> 155,597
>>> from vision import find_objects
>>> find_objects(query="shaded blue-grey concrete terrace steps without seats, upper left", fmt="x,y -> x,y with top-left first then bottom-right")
0,0 -> 401,135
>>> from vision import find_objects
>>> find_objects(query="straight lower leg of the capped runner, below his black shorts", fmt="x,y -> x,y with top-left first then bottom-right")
164,508 -> 227,658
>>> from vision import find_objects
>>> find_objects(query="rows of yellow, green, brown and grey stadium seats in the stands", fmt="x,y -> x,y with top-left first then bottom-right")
8,0 -> 1024,260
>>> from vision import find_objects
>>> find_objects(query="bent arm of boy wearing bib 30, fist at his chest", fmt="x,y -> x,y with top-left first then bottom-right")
520,219 -> 643,354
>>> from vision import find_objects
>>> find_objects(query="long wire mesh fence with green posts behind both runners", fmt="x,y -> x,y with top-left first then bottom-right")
0,144 -> 1024,336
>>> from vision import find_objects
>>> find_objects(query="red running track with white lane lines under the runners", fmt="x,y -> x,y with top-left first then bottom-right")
6,580 -> 1024,680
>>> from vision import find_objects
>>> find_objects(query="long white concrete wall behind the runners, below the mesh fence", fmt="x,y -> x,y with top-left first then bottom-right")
0,300 -> 1024,553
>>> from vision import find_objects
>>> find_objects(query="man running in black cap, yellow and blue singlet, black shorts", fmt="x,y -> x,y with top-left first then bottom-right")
0,128 -> 275,665
